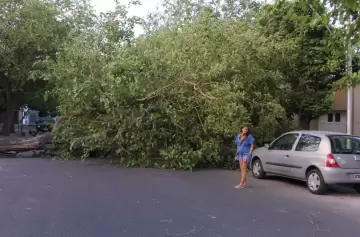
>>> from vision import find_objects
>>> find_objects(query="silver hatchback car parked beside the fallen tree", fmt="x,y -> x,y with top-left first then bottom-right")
251,131 -> 360,194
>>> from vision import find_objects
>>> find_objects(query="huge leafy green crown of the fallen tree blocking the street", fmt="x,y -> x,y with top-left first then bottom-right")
50,0 -> 297,168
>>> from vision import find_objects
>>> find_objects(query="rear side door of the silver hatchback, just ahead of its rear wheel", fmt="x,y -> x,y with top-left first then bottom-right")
289,133 -> 322,179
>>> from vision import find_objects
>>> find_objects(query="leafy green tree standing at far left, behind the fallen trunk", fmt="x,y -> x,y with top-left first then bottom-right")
0,0 -> 100,132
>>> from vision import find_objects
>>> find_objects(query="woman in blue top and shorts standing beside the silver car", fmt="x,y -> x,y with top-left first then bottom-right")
235,125 -> 255,189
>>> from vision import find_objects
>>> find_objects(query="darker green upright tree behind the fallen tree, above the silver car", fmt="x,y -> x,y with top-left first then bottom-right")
258,0 -> 345,129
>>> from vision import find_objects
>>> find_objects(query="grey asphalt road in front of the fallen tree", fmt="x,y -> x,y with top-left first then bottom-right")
0,159 -> 360,237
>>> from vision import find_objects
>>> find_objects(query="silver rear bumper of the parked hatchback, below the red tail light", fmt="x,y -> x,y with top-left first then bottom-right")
321,167 -> 360,184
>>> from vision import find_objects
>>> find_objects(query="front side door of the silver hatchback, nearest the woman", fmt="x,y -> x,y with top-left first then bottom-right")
264,133 -> 299,175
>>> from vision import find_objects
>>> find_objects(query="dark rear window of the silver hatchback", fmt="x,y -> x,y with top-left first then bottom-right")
328,135 -> 360,154
